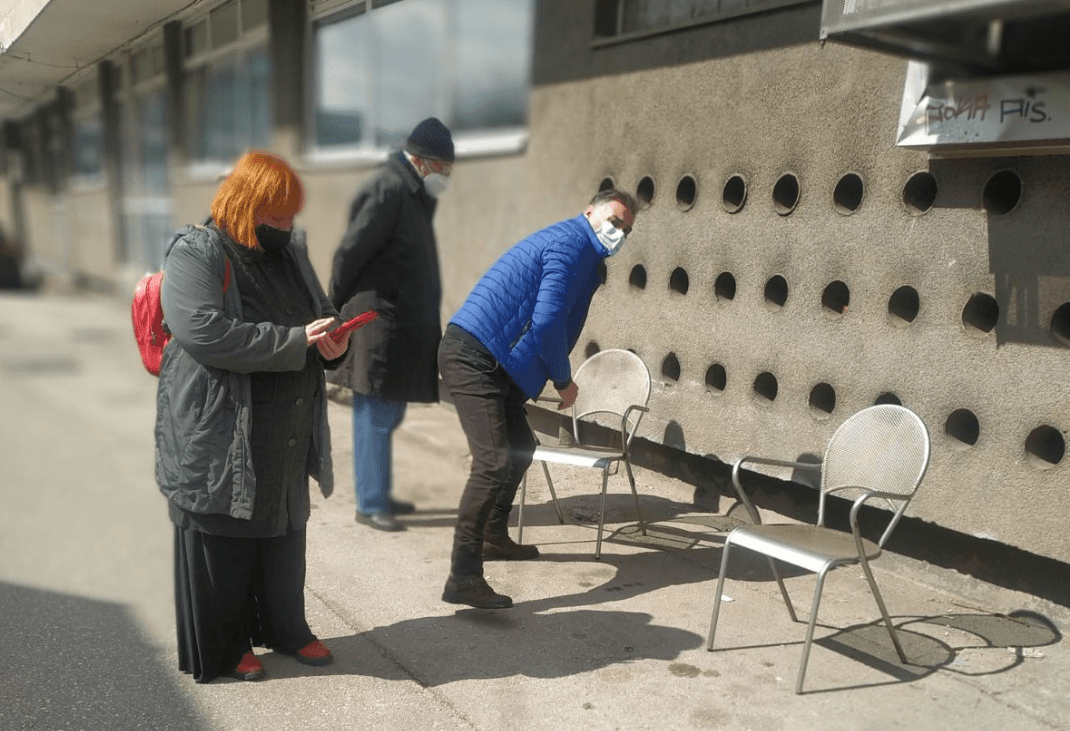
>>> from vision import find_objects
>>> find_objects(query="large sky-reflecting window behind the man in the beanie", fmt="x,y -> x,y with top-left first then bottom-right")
310,0 -> 534,159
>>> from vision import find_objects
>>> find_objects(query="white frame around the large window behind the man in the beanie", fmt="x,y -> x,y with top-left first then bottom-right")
302,0 -> 537,167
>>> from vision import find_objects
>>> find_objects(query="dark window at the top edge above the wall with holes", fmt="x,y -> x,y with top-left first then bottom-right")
595,0 -> 810,40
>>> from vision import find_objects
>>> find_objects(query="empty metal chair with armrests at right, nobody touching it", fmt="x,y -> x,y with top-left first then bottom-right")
706,405 -> 929,694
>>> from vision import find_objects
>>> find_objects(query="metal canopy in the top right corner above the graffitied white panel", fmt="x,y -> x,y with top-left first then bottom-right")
821,0 -> 1070,74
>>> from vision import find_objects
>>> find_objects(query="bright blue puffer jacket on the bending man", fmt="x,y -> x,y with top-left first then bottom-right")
450,214 -> 608,398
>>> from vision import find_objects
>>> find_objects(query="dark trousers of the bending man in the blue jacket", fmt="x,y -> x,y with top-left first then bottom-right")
439,325 -> 535,576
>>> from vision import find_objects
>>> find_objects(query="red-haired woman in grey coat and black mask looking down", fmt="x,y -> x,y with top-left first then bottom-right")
156,152 -> 349,683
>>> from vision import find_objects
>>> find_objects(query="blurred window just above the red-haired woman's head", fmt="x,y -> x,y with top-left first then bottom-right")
184,0 -> 272,174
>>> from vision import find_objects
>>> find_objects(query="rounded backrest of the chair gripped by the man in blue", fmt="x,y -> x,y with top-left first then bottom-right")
572,349 -> 651,439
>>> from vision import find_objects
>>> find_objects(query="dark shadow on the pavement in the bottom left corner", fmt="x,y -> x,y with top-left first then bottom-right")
0,582 -> 209,731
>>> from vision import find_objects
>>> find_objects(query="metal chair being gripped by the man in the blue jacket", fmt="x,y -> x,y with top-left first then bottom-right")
517,350 -> 651,559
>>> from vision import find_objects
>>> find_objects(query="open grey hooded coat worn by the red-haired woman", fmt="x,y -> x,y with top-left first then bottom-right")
156,226 -> 337,520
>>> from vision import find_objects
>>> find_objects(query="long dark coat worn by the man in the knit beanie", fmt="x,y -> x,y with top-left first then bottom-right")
328,152 -> 442,402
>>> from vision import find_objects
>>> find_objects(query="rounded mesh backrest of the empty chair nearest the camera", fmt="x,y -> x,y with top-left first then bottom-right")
819,403 -> 929,545
